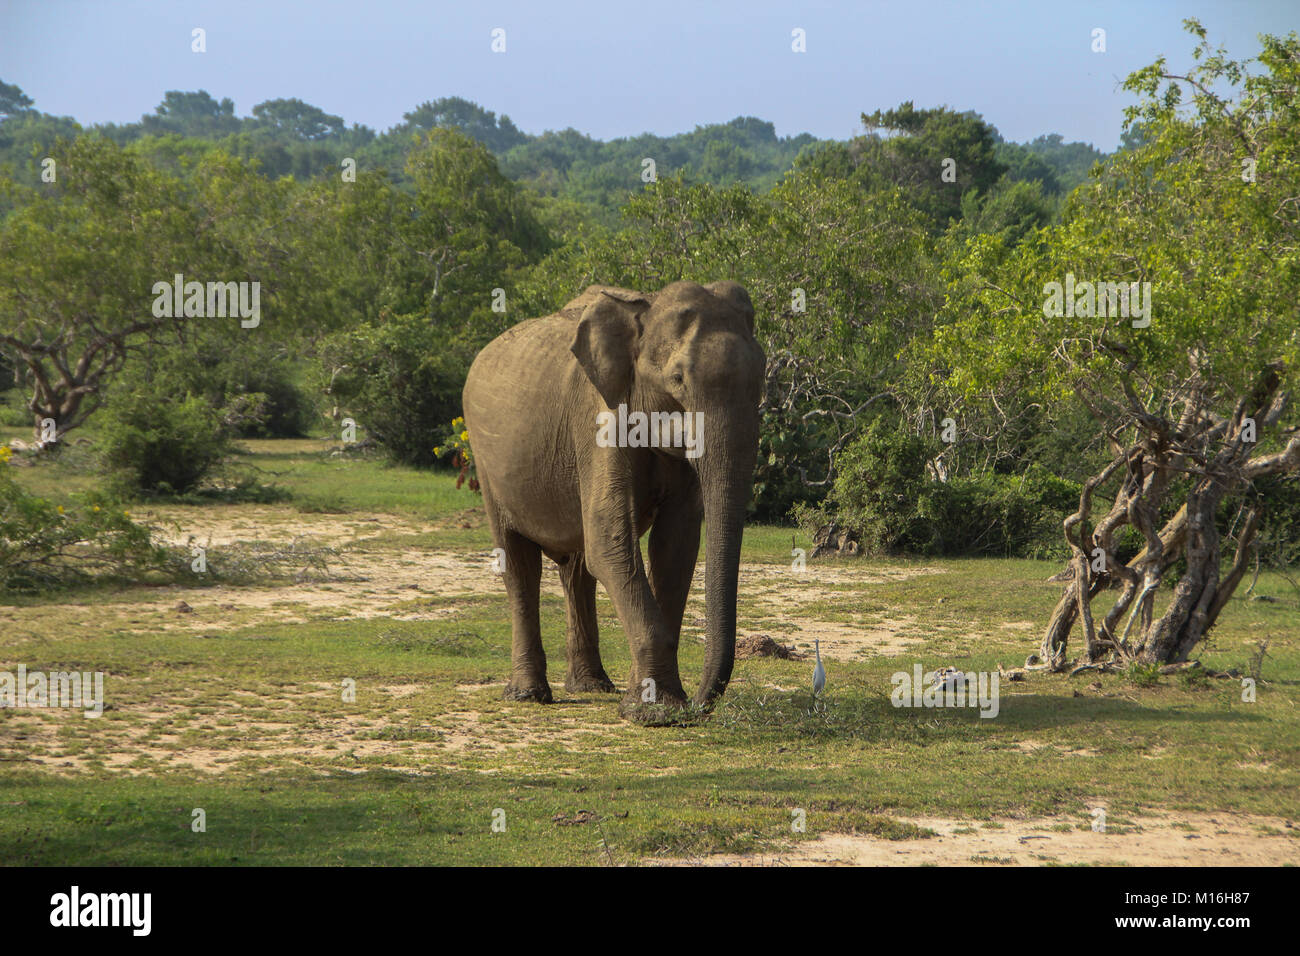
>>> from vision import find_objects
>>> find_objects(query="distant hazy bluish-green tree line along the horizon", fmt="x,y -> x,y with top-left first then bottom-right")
0,85 -> 1104,223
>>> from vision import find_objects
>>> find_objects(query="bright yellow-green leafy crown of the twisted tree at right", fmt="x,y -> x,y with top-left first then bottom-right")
927,23 -> 1300,423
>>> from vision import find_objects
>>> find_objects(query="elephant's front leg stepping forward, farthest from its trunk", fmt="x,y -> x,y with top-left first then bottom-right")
584,511 -> 686,719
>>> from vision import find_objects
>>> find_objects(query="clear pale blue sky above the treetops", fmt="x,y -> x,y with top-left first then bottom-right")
0,0 -> 1300,150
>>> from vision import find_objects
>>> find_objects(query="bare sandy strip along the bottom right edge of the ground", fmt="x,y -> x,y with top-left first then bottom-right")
660,813 -> 1300,866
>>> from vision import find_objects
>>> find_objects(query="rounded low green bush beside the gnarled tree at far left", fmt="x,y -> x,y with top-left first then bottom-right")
99,388 -> 233,496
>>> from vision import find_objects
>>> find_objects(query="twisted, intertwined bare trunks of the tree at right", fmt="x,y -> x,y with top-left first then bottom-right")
1031,368 -> 1300,671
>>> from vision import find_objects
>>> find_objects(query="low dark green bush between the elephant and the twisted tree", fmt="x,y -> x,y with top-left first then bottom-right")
816,419 -> 1079,558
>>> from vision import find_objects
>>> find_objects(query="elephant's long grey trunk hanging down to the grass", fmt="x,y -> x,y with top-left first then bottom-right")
696,420 -> 758,708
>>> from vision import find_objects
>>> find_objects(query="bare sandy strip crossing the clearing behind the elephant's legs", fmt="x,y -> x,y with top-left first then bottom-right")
0,505 -> 943,661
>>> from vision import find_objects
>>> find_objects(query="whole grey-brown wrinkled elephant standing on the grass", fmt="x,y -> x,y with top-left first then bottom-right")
464,282 -> 766,717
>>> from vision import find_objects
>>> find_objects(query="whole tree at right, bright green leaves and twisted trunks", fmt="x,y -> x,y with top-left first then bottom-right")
914,21 -> 1300,667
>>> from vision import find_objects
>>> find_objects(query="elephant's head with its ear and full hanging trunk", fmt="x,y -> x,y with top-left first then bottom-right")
572,282 -> 766,705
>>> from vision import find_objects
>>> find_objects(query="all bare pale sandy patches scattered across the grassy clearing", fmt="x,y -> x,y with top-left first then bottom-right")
0,506 -> 1300,866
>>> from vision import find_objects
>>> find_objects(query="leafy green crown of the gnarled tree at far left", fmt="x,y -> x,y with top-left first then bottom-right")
0,137 -> 309,434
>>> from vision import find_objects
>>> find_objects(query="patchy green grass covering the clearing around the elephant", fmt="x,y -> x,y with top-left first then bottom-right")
0,440 -> 1300,865
